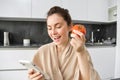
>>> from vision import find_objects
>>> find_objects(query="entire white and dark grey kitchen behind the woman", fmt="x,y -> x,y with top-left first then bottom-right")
0,0 -> 120,80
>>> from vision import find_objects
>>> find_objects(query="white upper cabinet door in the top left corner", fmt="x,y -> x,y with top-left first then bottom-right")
0,0 -> 31,18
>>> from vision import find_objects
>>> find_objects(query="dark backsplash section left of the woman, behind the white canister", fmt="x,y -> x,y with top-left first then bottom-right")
0,21 -> 51,45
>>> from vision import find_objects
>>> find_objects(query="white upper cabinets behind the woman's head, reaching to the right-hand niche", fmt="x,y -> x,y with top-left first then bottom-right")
32,0 -> 108,22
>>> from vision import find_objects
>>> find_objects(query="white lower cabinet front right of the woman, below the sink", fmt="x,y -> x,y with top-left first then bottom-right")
88,47 -> 116,80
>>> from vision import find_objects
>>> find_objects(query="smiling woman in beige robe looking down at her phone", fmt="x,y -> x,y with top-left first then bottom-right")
28,6 -> 100,80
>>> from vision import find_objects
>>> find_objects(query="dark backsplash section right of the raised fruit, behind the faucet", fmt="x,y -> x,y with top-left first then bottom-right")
75,22 -> 116,42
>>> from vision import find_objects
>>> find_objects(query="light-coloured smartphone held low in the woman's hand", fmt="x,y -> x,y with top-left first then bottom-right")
19,60 -> 50,80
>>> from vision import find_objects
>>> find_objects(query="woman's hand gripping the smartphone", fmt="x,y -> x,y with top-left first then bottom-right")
28,69 -> 43,80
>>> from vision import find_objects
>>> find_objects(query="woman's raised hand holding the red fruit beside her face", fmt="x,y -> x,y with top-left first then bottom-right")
70,30 -> 86,51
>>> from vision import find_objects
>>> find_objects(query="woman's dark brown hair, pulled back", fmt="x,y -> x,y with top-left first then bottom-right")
47,6 -> 72,26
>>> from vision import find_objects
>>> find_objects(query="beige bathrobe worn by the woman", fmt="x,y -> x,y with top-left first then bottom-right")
33,43 -> 100,80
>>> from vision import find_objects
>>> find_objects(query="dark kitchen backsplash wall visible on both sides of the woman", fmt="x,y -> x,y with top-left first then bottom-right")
0,21 -> 116,45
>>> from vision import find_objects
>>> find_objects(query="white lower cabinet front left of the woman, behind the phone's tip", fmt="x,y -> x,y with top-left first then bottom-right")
0,49 -> 36,70
